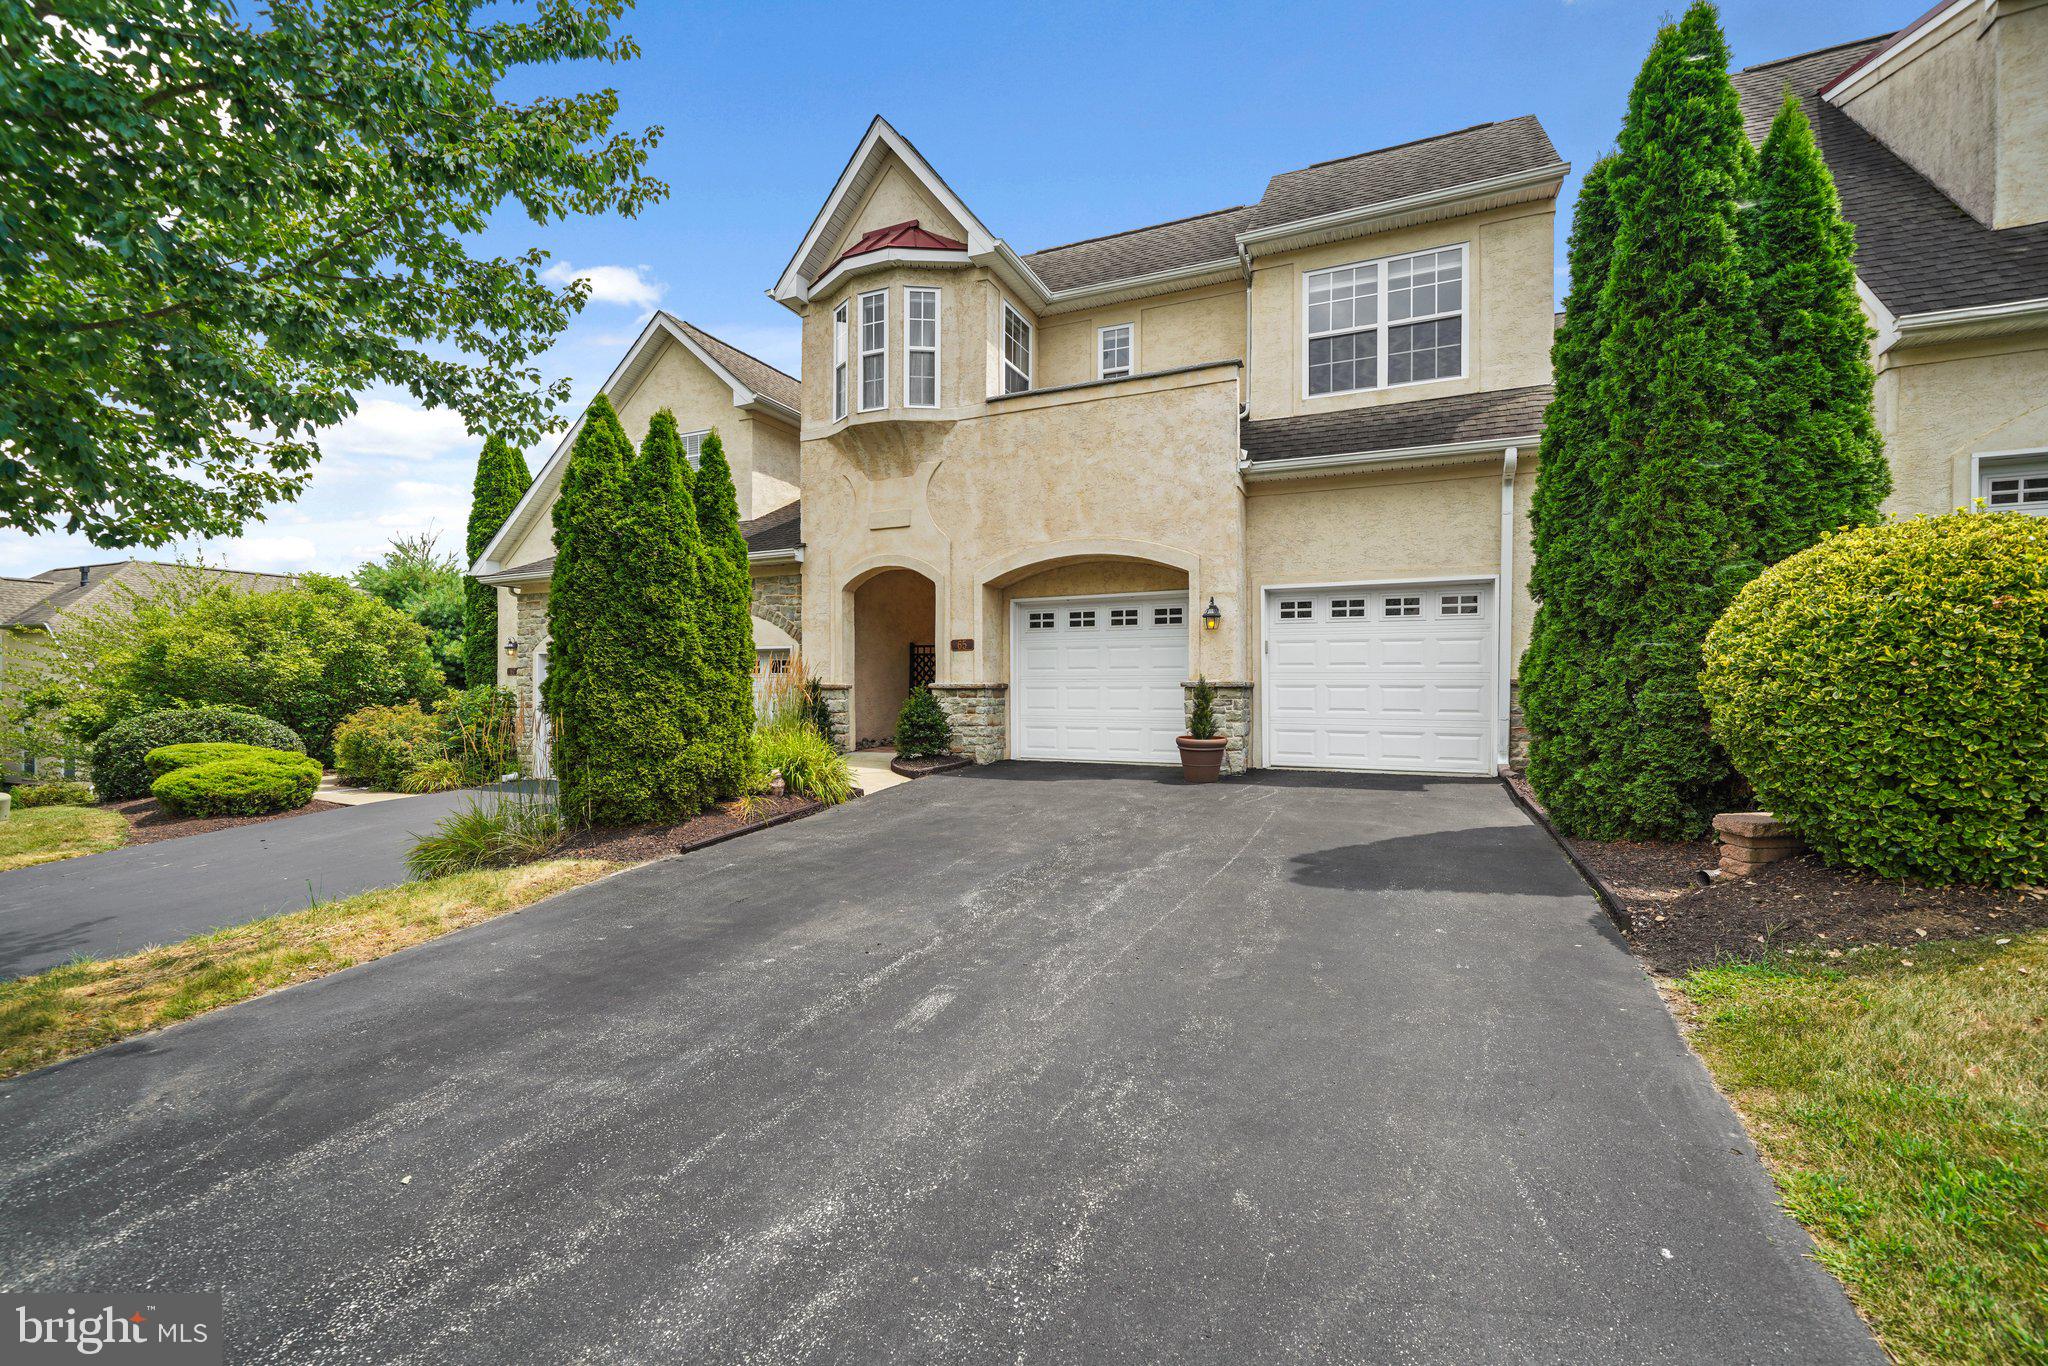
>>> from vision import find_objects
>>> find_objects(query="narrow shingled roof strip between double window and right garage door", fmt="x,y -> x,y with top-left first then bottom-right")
1239,385 -> 1550,465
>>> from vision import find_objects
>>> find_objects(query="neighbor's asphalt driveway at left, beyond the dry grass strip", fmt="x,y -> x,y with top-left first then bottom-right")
0,793 -> 475,979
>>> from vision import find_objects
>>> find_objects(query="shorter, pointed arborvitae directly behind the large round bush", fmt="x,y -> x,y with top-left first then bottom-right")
1743,92 -> 1892,563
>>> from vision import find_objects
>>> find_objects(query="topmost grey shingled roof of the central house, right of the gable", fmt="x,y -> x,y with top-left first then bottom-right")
1024,115 -> 1559,291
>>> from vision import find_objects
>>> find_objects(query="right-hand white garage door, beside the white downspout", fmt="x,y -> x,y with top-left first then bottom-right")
1264,584 -> 1495,774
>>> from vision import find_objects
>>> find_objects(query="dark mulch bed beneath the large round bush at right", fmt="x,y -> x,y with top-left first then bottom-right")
1513,778 -> 2048,973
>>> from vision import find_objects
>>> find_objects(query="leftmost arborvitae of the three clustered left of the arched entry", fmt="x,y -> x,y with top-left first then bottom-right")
543,393 -> 643,825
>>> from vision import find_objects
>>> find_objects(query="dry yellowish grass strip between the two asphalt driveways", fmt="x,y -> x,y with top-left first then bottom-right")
0,858 -> 616,1077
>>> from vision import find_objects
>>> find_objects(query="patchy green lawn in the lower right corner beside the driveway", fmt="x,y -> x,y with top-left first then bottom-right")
1681,930 -> 2048,1362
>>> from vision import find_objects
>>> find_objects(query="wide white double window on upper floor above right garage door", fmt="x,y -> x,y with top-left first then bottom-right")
1305,246 -> 1464,397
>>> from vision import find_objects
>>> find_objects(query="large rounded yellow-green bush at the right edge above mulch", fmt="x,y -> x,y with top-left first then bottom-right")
1700,512 -> 2048,887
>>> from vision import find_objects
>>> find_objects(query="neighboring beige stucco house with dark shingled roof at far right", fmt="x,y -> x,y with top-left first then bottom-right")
1735,0 -> 2048,514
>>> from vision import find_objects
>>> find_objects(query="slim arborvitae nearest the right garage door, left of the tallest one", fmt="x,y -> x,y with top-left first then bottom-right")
1522,158 -> 1626,829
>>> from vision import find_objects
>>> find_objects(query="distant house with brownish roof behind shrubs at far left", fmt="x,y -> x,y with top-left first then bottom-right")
0,559 -> 297,778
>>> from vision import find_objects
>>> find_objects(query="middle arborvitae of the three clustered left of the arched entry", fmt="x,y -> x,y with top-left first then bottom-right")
621,408 -> 711,821
